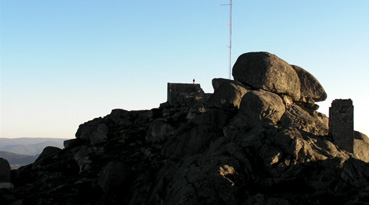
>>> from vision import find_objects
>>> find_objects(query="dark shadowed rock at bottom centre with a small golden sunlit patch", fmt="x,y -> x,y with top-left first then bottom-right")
165,156 -> 241,205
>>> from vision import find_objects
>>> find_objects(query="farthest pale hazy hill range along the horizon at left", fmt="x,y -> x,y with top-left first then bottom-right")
0,138 -> 67,156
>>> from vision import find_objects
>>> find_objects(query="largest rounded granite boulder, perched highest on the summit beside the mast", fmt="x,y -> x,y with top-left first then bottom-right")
232,52 -> 301,101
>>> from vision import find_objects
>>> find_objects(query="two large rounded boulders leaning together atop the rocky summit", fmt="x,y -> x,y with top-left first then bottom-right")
233,52 -> 327,106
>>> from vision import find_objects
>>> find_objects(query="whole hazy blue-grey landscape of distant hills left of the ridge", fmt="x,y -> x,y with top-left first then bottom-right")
0,138 -> 66,169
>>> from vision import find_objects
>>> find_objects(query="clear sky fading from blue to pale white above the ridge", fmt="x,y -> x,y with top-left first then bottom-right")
0,0 -> 369,138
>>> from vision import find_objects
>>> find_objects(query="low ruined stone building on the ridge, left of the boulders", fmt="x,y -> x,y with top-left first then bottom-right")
167,83 -> 202,104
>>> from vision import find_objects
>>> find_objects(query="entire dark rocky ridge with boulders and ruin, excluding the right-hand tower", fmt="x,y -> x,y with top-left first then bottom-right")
0,52 -> 369,205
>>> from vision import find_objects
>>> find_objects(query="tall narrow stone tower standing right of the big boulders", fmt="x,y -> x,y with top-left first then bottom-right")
329,99 -> 354,153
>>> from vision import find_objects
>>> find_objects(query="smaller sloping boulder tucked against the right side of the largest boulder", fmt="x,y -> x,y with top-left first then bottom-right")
291,65 -> 327,103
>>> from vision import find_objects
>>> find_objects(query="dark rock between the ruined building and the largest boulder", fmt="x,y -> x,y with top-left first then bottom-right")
207,79 -> 248,110
